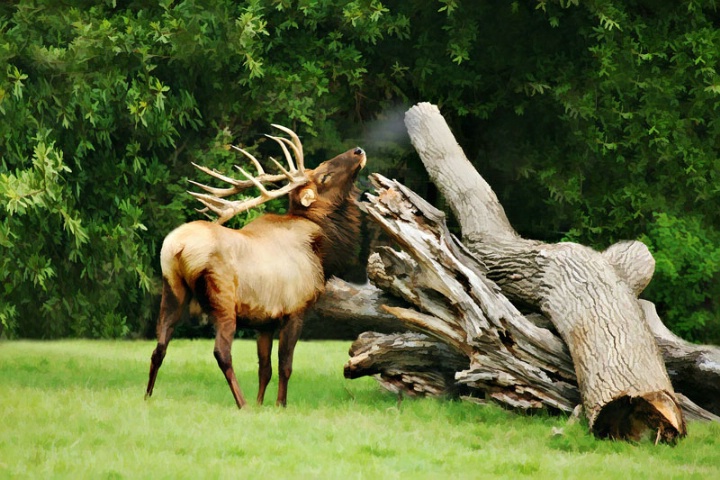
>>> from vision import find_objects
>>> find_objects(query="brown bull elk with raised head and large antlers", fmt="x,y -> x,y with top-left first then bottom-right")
145,125 -> 366,408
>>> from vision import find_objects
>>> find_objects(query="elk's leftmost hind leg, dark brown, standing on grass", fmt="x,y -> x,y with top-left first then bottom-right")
145,277 -> 189,399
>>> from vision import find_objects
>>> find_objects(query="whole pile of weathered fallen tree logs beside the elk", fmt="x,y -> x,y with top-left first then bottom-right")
330,104 -> 720,442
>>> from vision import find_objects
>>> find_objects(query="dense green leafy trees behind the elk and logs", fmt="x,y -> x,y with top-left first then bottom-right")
0,0 -> 720,343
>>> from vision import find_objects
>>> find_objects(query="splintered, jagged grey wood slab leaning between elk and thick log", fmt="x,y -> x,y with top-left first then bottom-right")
347,175 -> 580,412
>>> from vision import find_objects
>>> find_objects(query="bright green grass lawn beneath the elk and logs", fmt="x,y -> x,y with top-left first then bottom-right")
0,340 -> 720,479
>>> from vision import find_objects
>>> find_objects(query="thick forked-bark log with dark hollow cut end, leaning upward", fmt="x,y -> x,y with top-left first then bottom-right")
405,104 -> 685,441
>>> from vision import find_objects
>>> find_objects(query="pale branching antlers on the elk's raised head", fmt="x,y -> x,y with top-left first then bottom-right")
188,124 -> 309,224
